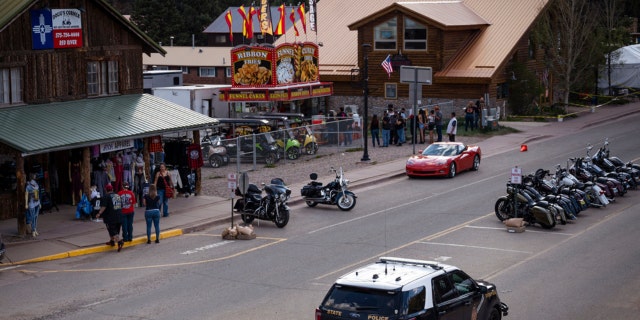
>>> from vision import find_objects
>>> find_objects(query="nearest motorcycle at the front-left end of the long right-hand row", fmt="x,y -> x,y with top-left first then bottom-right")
495,183 -> 556,229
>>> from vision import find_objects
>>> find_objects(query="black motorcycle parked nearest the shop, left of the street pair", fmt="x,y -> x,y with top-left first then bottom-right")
233,178 -> 291,228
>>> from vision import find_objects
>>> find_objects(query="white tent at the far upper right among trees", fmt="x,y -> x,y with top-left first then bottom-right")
598,44 -> 640,89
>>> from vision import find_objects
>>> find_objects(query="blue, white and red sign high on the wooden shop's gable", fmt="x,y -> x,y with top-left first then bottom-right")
30,9 -> 82,50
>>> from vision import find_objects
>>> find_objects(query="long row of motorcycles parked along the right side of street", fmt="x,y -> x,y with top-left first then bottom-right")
495,139 -> 640,229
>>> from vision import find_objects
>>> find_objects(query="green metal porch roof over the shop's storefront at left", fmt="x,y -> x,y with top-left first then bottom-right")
0,94 -> 217,156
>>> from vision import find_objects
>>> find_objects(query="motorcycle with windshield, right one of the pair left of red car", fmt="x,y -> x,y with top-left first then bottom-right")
300,167 -> 357,211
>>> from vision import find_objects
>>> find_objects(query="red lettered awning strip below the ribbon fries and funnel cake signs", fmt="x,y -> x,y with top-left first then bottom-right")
220,82 -> 333,102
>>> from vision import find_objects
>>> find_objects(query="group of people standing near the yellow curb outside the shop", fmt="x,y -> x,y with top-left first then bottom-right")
96,163 -> 173,252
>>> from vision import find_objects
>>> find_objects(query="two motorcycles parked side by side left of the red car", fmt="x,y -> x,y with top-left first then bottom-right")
233,167 -> 357,228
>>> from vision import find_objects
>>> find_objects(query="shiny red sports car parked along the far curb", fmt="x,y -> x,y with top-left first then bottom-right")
406,142 -> 482,178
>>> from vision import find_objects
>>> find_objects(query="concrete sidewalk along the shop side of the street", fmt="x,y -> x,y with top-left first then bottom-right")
0,103 -> 640,266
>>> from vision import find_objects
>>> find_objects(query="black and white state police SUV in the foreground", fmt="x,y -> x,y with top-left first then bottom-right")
315,257 -> 509,320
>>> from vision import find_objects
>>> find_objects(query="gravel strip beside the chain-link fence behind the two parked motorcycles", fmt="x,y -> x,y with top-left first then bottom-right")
201,135 -> 483,197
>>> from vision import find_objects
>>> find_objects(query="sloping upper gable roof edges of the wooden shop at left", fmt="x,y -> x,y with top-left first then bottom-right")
0,0 -> 167,56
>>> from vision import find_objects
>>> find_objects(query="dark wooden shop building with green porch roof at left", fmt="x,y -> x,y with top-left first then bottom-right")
0,0 -> 215,234
